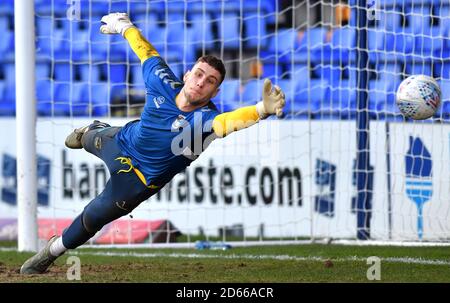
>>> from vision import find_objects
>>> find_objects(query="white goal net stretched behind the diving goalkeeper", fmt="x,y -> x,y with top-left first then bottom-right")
0,0 -> 450,248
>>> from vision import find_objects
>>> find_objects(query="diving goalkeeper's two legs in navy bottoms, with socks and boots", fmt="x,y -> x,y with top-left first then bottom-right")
20,121 -> 159,274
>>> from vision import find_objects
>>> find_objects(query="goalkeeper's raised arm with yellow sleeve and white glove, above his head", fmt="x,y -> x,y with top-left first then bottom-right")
100,13 -> 159,64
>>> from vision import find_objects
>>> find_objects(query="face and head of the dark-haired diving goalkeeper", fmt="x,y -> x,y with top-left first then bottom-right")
183,62 -> 221,106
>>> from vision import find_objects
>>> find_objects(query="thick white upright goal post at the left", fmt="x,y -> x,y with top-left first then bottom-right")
14,0 -> 38,251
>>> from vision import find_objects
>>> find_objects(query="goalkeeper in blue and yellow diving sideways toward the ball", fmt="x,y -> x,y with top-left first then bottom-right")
20,13 -> 285,274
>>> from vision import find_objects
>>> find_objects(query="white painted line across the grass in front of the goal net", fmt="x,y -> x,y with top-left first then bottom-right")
0,247 -> 450,266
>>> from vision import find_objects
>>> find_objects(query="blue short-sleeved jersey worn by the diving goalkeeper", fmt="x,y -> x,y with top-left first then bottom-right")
116,56 -> 219,186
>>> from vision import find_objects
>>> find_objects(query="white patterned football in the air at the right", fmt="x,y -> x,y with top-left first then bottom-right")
396,75 -> 441,120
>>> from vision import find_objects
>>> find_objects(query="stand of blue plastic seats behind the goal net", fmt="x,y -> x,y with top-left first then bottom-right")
0,0 -> 450,119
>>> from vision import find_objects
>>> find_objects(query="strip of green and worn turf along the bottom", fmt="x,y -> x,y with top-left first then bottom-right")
0,243 -> 450,283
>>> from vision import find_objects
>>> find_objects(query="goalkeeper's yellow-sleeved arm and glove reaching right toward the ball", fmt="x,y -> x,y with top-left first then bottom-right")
213,79 -> 286,138
